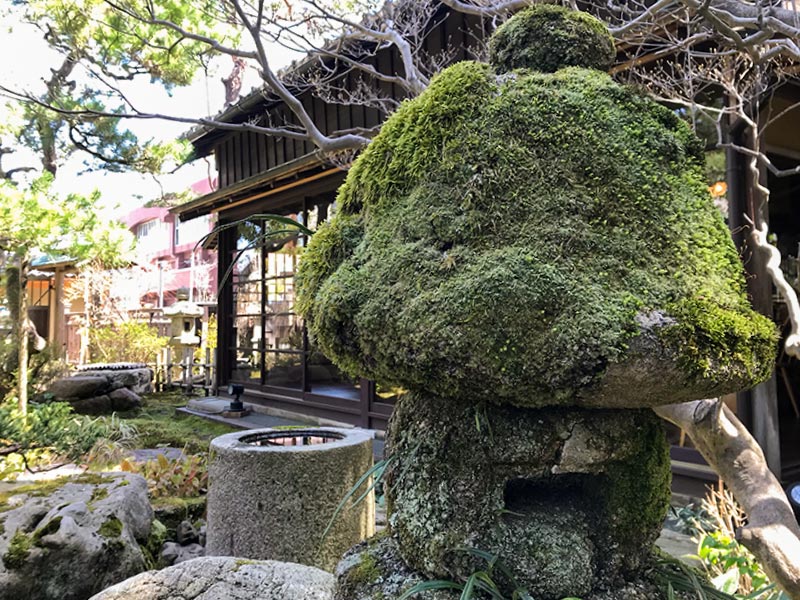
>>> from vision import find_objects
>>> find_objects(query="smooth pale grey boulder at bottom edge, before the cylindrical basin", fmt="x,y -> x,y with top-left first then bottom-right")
90,557 -> 334,600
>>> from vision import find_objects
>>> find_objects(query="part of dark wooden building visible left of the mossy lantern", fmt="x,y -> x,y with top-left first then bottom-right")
174,5 -> 485,429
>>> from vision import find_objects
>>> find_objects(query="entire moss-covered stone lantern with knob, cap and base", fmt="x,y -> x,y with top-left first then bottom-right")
298,6 -> 776,600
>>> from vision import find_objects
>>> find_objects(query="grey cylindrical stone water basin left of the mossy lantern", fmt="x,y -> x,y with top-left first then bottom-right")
206,427 -> 375,571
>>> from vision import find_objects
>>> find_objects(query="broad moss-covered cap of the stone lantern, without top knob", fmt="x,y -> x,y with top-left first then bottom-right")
298,9 -> 776,407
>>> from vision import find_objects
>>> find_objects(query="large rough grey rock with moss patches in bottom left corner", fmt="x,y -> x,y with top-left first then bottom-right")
0,473 -> 153,600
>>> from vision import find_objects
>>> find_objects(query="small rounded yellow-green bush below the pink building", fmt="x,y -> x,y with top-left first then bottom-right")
89,321 -> 169,363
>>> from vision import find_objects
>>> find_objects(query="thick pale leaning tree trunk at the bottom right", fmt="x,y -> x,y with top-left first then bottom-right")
655,399 -> 800,600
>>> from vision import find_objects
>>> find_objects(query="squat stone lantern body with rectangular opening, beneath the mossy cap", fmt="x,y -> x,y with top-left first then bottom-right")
386,393 -> 670,599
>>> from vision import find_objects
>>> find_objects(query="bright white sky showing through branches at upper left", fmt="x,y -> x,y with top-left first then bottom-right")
0,10 -> 293,216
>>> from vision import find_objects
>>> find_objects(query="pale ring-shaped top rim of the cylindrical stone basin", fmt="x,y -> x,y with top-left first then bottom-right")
211,427 -> 375,453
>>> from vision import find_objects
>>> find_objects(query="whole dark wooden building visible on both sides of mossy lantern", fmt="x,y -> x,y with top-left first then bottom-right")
173,4 -> 800,492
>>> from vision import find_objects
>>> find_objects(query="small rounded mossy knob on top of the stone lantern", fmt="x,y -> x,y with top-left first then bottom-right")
489,5 -> 616,73
